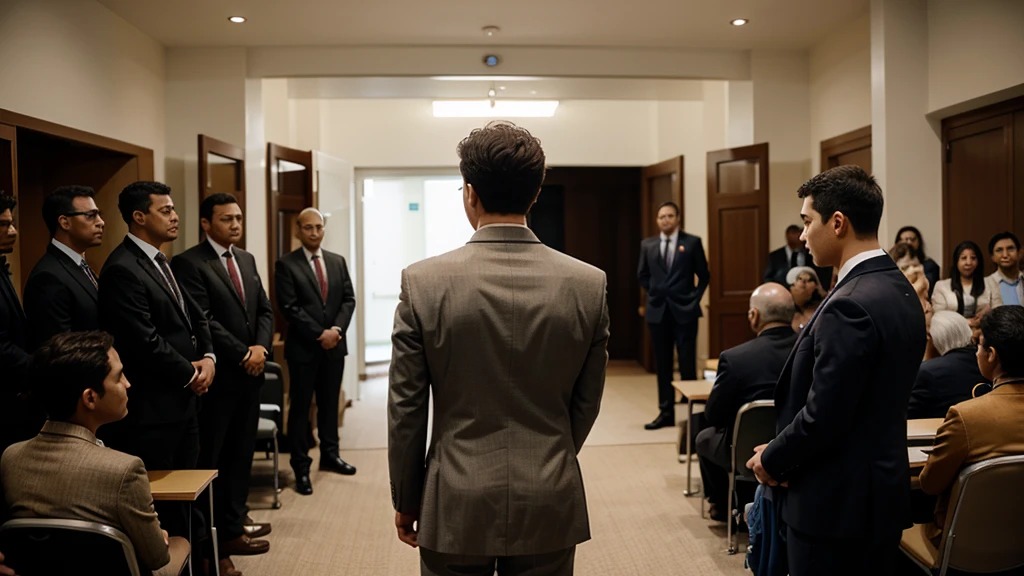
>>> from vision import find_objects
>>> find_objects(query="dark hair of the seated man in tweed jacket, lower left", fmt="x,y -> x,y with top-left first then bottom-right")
31,331 -> 114,420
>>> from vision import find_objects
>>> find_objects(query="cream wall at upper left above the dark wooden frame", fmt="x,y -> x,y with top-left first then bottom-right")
0,0 -> 165,174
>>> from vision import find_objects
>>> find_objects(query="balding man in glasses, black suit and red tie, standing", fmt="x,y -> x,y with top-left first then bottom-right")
273,208 -> 355,495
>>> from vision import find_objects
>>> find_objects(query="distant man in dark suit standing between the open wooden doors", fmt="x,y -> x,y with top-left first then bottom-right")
637,202 -> 711,430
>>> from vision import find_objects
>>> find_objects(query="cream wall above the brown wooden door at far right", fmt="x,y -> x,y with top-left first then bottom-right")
928,0 -> 1024,112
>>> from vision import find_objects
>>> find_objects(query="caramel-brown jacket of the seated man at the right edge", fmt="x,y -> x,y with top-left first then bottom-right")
921,380 -> 1024,538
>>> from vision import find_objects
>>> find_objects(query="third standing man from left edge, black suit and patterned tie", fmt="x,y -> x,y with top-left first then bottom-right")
99,181 -> 217,536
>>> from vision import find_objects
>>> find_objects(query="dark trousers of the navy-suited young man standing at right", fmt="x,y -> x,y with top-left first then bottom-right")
785,519 -> 901,576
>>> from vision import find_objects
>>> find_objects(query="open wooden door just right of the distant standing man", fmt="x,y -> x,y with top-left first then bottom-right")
708,143 -> 768,358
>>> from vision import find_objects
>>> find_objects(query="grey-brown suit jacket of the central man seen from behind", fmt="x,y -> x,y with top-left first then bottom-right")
388,225 -> 608,556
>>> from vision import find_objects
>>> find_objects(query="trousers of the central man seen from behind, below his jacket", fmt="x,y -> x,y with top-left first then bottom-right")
420,546 -> 575,576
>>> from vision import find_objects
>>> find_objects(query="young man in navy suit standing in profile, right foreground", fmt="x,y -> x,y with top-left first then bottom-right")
746,166 -> 926,576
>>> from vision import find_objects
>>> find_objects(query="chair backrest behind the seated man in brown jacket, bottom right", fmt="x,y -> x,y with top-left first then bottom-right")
939,455 -> 1024,572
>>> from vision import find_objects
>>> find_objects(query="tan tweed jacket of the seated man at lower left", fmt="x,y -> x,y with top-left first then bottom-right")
0,420 -> 171,570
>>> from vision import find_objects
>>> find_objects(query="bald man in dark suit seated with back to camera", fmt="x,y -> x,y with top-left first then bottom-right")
696,283 -> 797,522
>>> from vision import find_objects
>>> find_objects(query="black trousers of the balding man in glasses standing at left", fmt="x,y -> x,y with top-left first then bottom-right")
288,354 -> 345,472
